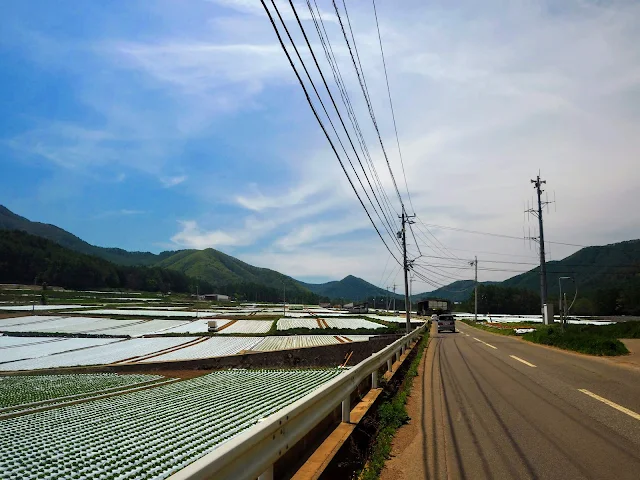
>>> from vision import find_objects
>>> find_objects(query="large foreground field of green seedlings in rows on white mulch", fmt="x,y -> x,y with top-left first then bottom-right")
0,369 -> 342,480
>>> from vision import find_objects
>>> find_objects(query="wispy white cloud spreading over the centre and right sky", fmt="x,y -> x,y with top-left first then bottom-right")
6,0 -> 640,282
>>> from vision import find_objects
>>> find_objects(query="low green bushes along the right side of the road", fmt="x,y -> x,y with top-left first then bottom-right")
522,325 -> 629,356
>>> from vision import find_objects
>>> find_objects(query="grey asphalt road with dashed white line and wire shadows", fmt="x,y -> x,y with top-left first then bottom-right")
382,322 -> 640,480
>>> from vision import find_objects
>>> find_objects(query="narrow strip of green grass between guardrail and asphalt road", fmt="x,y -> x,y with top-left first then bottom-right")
358,332 -> 429,480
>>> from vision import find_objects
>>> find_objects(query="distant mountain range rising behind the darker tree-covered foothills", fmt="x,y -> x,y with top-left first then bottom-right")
0,205 -> 640,301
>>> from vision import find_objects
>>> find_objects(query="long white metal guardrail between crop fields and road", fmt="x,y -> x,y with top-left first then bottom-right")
169,324 -> 426,480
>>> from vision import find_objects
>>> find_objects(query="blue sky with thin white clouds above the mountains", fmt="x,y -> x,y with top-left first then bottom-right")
0,0 -> 640,289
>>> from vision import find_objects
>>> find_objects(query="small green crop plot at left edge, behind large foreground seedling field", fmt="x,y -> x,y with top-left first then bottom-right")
0,373 -> 164,408
